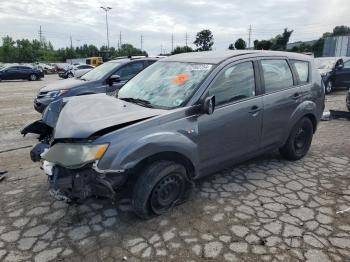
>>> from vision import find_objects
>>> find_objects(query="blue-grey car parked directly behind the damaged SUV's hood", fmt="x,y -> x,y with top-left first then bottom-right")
34,58 -> 158,113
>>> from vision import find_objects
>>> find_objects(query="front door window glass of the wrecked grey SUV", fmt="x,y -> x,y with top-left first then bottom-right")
209,62 -> 255,106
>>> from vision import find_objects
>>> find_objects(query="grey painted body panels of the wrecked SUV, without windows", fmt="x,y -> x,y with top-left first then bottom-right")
47,51 -> 324,177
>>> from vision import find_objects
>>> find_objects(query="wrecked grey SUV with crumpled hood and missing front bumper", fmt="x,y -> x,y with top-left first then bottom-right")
25,50 -> 324,218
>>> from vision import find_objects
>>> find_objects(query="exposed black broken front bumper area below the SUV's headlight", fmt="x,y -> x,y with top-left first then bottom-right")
42,161 -> 126,203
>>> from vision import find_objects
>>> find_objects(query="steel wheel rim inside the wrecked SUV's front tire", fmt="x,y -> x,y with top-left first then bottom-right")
151,174 -> 183,214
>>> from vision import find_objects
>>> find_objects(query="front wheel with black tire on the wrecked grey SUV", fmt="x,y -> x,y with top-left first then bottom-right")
132,161 -> 191,219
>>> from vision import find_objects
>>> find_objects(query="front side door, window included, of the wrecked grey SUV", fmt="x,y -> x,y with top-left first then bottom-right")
198,61 -> 263,173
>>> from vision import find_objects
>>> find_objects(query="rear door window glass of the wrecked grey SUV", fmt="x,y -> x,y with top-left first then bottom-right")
261,59 -> 293,93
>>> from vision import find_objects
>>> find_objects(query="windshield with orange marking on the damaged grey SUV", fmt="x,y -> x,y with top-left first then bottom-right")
118,61 -> 213,109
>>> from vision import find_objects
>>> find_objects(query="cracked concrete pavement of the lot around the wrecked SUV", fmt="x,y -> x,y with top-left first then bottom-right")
0,76 -> 350,262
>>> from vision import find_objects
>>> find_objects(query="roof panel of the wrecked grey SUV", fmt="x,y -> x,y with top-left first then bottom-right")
162,50 -> 313,64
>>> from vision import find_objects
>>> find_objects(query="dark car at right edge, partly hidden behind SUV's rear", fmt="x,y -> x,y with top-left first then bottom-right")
315,57 -> 350,94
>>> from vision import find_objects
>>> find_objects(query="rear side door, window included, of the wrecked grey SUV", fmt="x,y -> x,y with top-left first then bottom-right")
259,57 -> 301,149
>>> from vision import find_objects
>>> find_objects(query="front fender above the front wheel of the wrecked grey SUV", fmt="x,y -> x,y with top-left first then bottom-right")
98,132 -> 199,173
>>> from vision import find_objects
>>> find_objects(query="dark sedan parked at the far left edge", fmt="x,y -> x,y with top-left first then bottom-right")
0,66 -> 44,81
